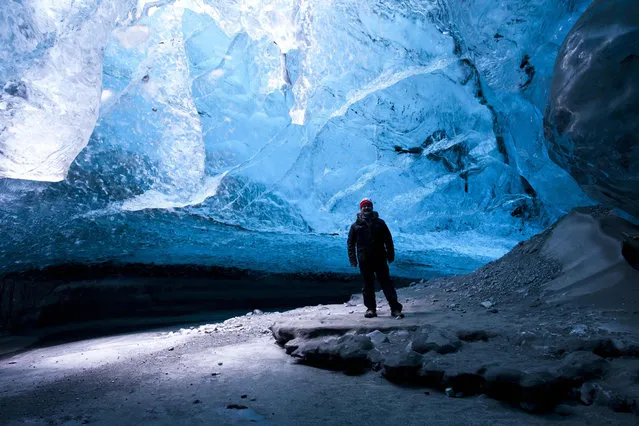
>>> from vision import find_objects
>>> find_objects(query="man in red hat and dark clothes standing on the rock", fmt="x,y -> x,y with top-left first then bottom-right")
348,198 -> 404,318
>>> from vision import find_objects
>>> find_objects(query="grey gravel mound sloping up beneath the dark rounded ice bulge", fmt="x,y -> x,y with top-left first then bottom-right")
408,206 -> 639,313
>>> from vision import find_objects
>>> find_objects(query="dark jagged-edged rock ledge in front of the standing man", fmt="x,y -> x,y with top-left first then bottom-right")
271,313 -> 639,414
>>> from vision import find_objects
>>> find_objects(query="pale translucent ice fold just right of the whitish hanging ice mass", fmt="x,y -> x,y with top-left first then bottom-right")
95,5 -> 209,210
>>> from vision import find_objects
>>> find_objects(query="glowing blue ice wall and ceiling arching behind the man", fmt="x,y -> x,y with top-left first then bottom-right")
0,0 -> 591,274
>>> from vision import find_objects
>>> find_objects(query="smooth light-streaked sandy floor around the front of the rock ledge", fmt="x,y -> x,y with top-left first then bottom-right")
0,294 -> 636,425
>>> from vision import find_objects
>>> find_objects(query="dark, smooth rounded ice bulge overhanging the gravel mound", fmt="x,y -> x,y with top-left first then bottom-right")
545,0 -> 639,217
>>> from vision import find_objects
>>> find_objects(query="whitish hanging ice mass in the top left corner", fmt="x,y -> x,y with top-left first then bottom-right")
0,0 -> 132,181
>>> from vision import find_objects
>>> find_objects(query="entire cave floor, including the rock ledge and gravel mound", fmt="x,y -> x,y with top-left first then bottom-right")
0,209 -> 639,425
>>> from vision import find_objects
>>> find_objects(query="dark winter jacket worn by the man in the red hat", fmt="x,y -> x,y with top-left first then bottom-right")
348,212 -> 395,265
